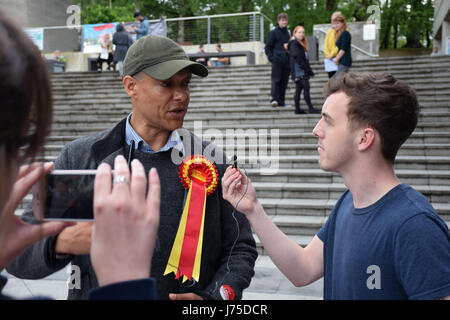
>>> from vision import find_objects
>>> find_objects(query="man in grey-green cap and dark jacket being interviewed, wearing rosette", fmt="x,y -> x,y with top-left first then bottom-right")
7,36 -> 257,300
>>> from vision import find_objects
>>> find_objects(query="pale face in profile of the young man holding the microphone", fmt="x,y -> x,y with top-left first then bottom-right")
313,92 -> 357,173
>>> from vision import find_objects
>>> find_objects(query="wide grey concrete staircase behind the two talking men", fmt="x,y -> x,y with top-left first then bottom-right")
15,56 -> 450,299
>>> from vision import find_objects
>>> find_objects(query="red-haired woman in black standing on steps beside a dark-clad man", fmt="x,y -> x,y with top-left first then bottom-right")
288,26 -> 319,114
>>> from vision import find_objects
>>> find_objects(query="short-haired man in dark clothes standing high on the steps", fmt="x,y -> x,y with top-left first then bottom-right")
264,13 -> 290,107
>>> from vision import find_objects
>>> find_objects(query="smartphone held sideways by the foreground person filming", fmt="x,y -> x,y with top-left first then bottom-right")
32,170 -> 96,221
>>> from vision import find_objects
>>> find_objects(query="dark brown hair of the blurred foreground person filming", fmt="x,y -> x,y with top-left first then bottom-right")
0,11 -> 52,160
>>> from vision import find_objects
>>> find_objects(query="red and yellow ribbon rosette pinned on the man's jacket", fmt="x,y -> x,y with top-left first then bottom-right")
164,155 -> 219,282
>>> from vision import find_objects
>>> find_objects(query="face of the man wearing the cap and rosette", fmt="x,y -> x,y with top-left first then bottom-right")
127,69 -> 192,131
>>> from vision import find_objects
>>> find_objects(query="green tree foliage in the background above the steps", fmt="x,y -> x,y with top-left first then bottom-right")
74,0 -> 434,48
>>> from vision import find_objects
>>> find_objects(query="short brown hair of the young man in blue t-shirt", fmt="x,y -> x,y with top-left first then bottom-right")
325,72 -> 419,163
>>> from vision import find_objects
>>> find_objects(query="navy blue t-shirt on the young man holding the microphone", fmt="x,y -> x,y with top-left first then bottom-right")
317,184 -> 450,299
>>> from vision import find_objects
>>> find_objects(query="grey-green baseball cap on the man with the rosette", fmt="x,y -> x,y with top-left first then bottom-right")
123,35 -> 208,80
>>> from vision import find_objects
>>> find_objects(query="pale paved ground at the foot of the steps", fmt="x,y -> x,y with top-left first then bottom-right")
1,256 -> 323,300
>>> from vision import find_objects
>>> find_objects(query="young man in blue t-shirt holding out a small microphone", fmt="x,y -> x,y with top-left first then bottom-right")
222,73 -> 450,299
